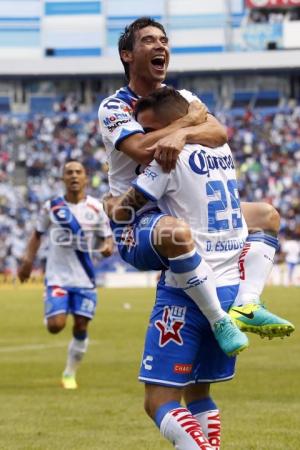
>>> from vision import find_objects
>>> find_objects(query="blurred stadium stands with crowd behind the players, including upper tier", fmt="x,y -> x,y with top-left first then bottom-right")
0,0 -> 300,282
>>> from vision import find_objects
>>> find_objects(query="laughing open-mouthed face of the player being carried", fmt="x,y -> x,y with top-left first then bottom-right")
121,26 -> 170,95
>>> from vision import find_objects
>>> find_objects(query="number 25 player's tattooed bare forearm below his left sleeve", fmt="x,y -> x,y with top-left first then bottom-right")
104,187 -> 149,223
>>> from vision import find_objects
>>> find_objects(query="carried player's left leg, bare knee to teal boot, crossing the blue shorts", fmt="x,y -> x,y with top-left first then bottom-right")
153,216 -> 248,356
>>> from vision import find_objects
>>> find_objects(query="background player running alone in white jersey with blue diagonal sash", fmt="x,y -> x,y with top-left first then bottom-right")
19,161 -> 113,389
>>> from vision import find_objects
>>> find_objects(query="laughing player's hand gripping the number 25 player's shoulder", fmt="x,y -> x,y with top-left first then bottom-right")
149,130 -> 186,172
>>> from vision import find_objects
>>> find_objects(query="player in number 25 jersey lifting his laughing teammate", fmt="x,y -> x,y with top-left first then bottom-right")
107,87 -> 296,450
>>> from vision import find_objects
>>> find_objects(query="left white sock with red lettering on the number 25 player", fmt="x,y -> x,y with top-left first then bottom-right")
160,408 -> 212,450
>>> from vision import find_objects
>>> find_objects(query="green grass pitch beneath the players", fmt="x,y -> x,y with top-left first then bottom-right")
0,285 -> 300,450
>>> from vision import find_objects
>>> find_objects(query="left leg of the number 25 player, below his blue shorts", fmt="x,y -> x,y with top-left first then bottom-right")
145,384 -> 214,450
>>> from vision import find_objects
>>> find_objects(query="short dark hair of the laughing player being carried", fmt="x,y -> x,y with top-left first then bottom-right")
118,17 -> 167,81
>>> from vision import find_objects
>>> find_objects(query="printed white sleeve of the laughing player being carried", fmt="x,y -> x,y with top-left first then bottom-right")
98,97 -> 144,151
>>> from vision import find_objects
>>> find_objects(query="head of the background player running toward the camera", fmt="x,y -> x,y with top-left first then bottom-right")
63,161 -> 87,196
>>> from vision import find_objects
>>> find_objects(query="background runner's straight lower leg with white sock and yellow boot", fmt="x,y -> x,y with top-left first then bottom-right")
62,315 -> 89,389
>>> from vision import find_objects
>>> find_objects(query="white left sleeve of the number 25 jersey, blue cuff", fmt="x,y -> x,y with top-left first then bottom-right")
132,161 -> 170,201
